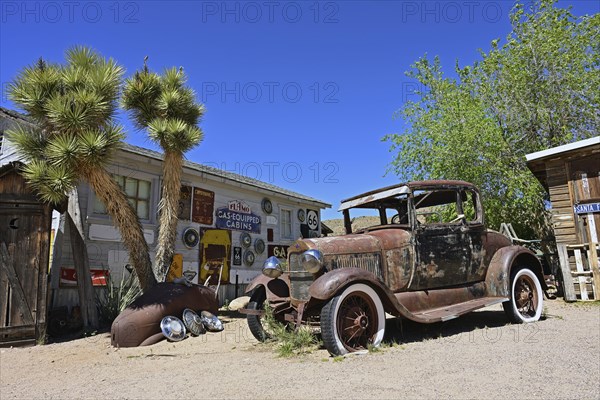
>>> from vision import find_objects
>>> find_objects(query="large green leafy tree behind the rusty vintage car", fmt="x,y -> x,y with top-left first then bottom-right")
384,0 -> 600,238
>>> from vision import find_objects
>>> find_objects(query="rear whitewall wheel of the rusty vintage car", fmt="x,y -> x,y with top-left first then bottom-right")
502,267 -> 543,324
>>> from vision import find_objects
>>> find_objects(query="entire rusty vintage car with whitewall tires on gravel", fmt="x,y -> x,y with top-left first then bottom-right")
244,181 -> 545,355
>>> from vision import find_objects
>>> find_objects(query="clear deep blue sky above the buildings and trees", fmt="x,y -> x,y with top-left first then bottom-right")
0,0 -> 600,219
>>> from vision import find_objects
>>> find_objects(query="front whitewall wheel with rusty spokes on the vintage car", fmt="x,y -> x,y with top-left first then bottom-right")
321,283 -> 385,356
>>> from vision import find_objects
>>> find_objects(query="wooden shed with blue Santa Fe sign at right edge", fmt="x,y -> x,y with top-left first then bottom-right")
527,136 -> 600,301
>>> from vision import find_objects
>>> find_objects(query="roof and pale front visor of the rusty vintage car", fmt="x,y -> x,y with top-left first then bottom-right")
338,180 -> 477,211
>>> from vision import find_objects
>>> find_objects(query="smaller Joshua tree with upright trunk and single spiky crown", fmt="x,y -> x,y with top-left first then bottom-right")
122,61 -> 204,282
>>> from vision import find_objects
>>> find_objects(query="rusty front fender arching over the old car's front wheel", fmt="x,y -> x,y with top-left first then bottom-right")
308,268 -> 412,319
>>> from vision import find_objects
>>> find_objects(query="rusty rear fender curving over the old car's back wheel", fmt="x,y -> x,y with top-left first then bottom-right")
485,246 -> 548,297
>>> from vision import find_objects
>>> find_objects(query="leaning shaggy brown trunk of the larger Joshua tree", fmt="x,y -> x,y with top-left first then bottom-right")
84,168 -> 156,292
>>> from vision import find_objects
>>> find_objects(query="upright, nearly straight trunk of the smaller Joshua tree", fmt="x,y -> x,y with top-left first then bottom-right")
154,151 -> 183,282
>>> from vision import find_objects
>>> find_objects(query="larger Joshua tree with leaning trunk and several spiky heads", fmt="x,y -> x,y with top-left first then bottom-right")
8,47 -> 156,290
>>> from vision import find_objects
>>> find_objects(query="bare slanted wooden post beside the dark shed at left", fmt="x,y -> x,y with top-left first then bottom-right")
66,189 -> 99,329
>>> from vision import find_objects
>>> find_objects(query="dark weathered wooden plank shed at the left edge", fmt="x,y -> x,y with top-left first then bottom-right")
0,163 -> 52,346
